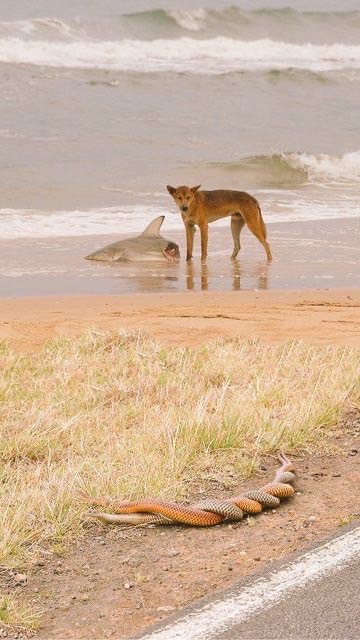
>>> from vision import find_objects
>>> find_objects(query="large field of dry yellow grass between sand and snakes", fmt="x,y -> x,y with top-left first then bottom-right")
0,331 -> 360,566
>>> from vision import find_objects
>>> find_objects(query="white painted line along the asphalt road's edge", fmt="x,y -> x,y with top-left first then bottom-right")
142,527 -> 360,640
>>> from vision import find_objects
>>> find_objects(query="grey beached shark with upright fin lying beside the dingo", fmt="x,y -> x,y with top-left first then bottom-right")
85,216 -> 180,262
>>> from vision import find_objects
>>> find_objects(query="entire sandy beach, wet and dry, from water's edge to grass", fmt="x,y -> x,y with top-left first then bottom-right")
0,219 -> 360,351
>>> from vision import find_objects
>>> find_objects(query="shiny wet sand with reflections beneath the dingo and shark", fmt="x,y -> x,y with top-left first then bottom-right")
0,218 -> 360,297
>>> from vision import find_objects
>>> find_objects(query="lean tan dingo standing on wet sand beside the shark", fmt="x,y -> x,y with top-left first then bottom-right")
167,185 -> 272,261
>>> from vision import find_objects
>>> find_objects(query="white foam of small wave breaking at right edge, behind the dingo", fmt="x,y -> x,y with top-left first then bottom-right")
283,151 -> 360,182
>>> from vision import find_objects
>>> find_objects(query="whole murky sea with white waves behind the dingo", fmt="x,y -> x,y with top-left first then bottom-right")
0,0 -> 360,242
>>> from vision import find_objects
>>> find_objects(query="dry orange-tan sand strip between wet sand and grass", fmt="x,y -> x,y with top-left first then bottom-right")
0,288 -> 360,352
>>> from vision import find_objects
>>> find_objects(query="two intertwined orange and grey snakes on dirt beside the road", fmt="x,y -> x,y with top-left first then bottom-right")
84,451 -> 295,527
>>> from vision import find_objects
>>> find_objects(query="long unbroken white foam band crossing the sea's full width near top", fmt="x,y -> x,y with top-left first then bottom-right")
0,37 -> 360,74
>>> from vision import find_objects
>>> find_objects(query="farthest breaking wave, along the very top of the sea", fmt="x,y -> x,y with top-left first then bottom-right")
0,5 -> 360,43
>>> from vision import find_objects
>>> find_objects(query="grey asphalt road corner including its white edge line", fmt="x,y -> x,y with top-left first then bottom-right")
139,524 -> 360,640
